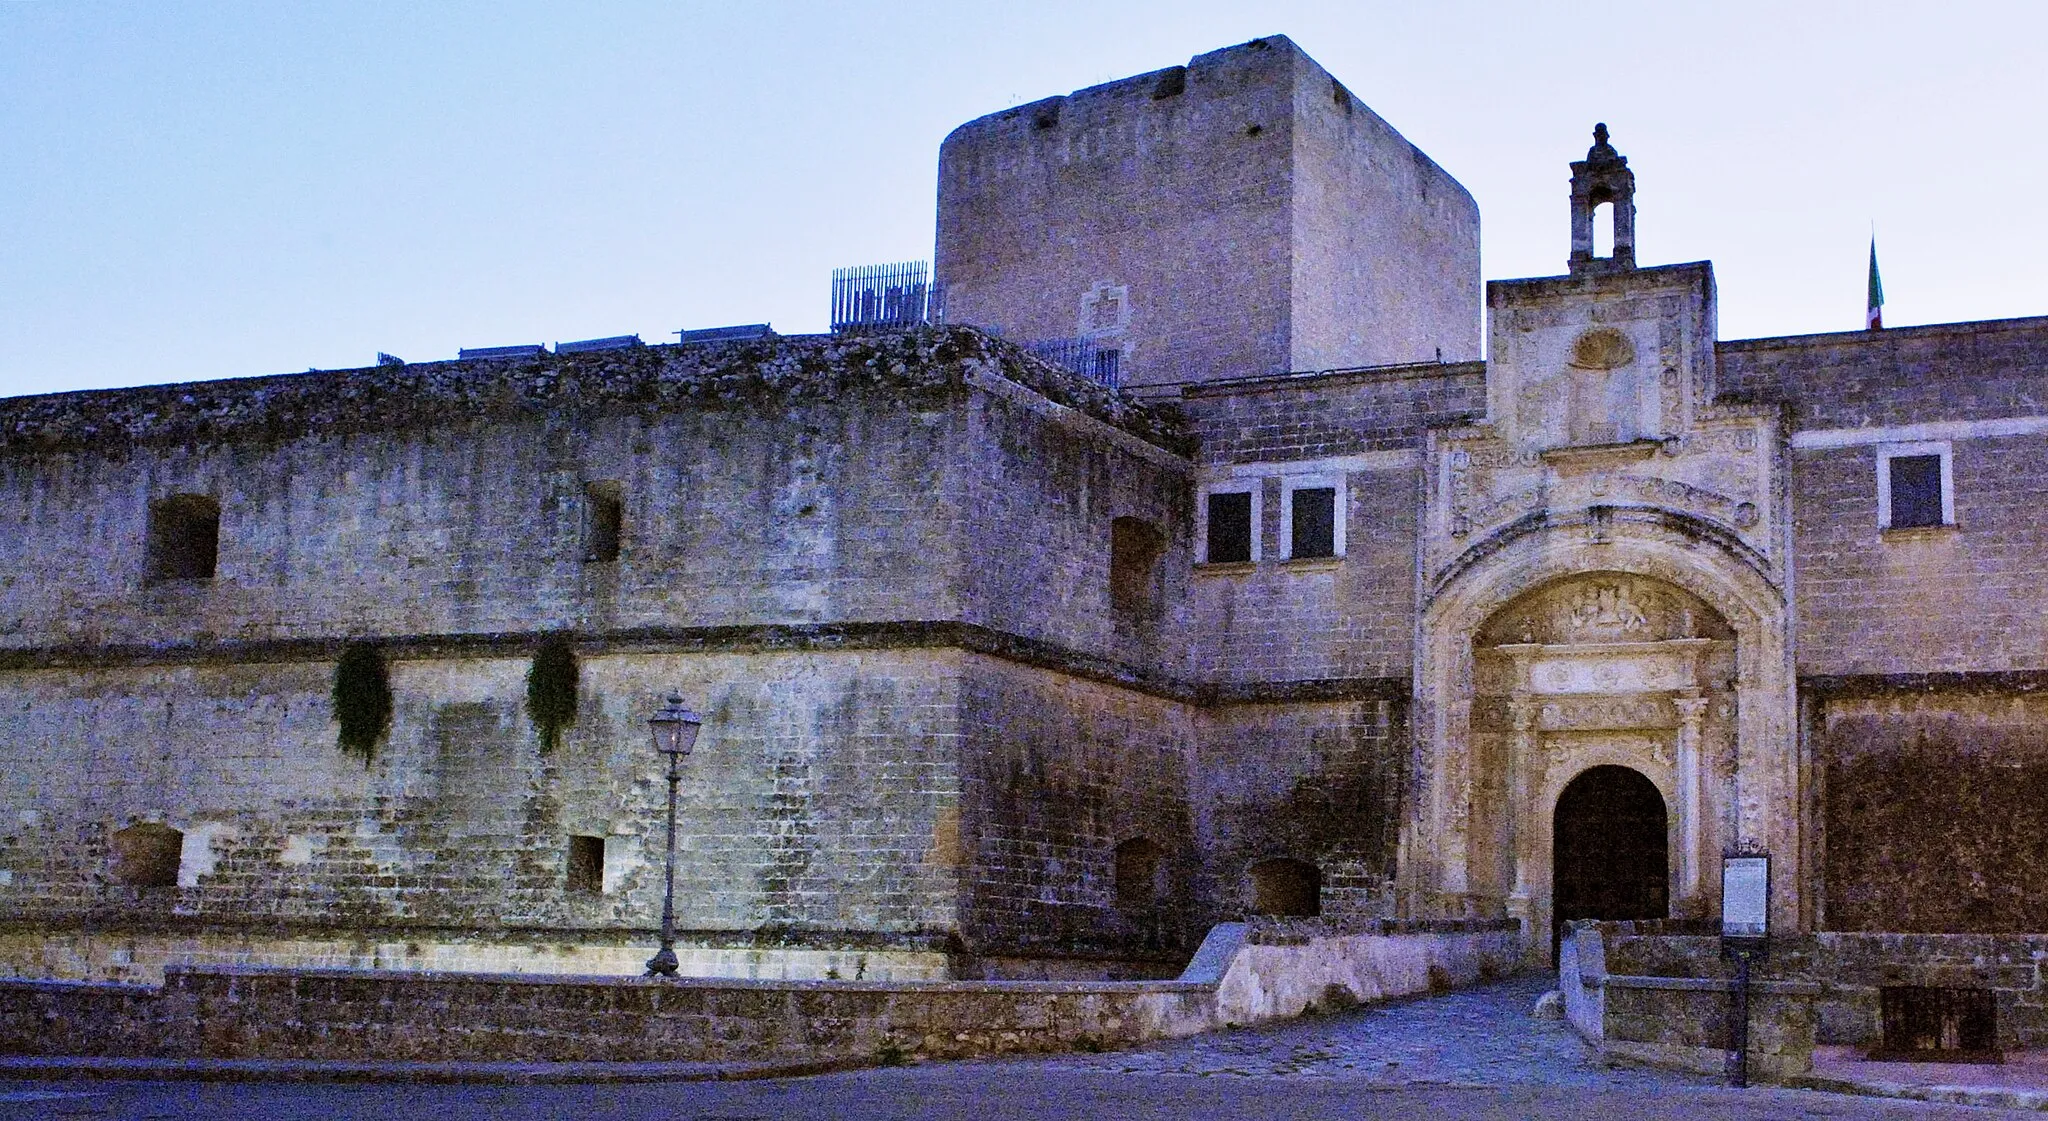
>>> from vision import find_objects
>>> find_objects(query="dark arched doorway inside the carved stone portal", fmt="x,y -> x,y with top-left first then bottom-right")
1550,766 -> 1671,965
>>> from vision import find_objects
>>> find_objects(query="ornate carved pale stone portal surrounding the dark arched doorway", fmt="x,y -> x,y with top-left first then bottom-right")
1401,142 -> 1810,957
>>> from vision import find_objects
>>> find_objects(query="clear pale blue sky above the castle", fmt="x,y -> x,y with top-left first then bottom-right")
0,0 -> 2048,396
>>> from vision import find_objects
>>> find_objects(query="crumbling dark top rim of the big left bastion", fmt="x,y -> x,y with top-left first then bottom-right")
0,326 -> 1196,457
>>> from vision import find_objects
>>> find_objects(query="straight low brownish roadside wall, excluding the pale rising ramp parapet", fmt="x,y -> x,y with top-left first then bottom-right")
0,969 -> 1217,1062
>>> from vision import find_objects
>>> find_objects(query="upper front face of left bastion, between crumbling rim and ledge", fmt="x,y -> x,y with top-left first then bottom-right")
0,372 -> 963,646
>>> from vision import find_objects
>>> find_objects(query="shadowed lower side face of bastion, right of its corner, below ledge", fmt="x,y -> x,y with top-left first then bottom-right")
961,658 -> 1208,957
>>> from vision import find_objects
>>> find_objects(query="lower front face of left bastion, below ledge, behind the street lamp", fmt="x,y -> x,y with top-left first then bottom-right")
0,650 -> 961,959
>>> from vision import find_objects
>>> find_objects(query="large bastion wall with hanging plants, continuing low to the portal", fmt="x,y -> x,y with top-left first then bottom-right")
0,330 -> 1433,978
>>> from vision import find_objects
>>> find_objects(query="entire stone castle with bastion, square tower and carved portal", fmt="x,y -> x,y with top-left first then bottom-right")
0,37 -> 2048,980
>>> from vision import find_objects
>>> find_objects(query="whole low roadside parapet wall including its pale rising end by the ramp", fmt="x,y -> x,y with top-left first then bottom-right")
0,926 -> 1522,1062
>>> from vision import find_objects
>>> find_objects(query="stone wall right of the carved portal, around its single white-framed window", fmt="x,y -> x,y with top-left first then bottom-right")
1720,320 -> 2048,932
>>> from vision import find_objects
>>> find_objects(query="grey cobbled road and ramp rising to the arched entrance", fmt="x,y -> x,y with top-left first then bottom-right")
0,978 -> 2042,1121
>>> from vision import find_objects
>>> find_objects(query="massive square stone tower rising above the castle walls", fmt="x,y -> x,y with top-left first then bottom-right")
938,35 -> 1481,387
